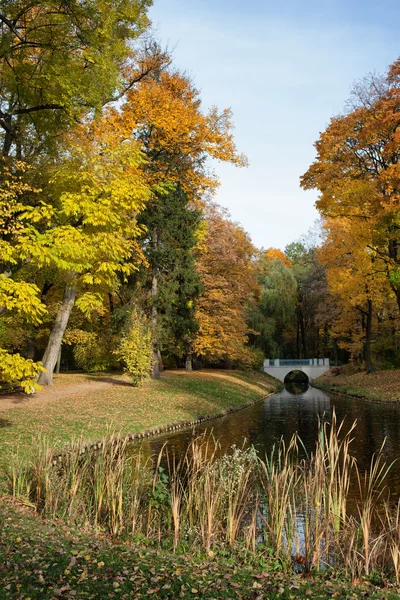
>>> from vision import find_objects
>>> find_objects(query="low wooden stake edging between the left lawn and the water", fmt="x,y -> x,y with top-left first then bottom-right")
53,390 -> 278,465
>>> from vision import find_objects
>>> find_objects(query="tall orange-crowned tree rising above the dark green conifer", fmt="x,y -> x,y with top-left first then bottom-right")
115,69 -> 246,377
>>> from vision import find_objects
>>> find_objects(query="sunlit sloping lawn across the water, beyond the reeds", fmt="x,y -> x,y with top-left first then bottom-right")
0,371 -> 277,468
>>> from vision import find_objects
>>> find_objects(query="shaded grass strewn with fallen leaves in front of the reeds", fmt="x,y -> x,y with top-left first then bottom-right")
0,502 -> 399,600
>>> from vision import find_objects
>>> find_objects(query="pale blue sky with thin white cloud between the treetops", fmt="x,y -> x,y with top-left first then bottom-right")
149,0 -> 400,249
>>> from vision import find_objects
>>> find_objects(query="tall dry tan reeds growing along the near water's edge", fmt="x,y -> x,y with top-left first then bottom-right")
5,415 -> 400,582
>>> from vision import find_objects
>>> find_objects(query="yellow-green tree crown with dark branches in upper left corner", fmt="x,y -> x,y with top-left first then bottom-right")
0,0 -> 151,161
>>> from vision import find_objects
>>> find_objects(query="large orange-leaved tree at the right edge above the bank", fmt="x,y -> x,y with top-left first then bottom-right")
302,60 -> 400,370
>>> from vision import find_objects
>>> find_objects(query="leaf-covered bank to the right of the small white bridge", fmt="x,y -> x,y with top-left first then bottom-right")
313,365 -> 400,402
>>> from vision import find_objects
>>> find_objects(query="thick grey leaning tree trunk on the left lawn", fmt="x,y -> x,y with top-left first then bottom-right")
39,287 -> 76,385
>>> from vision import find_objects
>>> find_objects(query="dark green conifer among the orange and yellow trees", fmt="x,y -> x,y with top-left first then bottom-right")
139,187 -> 202,370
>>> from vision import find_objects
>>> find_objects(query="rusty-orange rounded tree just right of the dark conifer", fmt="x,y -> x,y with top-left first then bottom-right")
193,206 -> 259,364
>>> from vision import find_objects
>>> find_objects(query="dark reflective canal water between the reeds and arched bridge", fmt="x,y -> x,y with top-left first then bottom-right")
143,383 -> 400,498
